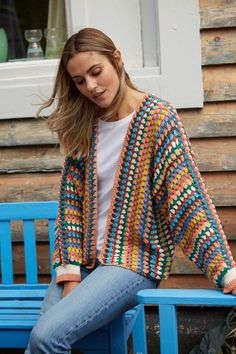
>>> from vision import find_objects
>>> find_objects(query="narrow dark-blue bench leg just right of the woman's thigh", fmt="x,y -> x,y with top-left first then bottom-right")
132,305 -> 147,354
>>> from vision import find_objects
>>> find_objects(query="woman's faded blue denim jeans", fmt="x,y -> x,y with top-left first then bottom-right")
25,264 -> 158,354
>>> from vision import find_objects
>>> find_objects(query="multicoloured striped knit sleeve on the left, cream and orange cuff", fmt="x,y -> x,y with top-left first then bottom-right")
53,157 -> 84,283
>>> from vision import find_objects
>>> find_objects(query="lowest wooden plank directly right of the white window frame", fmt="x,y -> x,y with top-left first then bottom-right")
202,65 -> 236,102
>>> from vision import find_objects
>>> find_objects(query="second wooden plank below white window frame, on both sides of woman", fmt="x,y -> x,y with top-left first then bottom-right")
0,138 -> 236,173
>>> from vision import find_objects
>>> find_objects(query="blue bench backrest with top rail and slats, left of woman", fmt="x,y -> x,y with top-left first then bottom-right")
0,201 -> 58,285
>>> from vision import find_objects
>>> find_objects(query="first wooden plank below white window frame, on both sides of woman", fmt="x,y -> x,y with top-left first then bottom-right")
0,101 -> 236,147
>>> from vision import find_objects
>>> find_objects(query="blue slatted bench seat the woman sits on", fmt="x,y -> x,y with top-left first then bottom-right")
0,284 -> 140,354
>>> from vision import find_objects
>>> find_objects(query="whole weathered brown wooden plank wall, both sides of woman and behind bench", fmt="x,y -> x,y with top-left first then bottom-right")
0,0 -> 236,288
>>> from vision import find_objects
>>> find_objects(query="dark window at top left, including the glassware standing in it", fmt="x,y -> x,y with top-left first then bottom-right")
0,0 -> 67,61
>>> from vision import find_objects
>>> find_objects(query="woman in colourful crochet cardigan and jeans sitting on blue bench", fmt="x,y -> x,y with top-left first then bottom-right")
26,28 -> 236,354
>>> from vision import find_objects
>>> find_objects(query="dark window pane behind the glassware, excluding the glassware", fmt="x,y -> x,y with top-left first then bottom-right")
0,0 -> 66,60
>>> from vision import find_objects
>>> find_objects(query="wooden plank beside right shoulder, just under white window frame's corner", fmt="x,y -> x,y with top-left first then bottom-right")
178,101 -> 236,138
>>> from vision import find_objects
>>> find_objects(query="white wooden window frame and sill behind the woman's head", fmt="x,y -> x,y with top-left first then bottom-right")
0,0 -> 203,118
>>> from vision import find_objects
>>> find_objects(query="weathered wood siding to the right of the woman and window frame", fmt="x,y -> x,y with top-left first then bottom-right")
162,0 -> 236,287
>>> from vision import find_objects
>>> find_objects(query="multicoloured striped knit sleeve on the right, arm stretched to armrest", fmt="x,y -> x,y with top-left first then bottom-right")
155,104 -> 235,287
